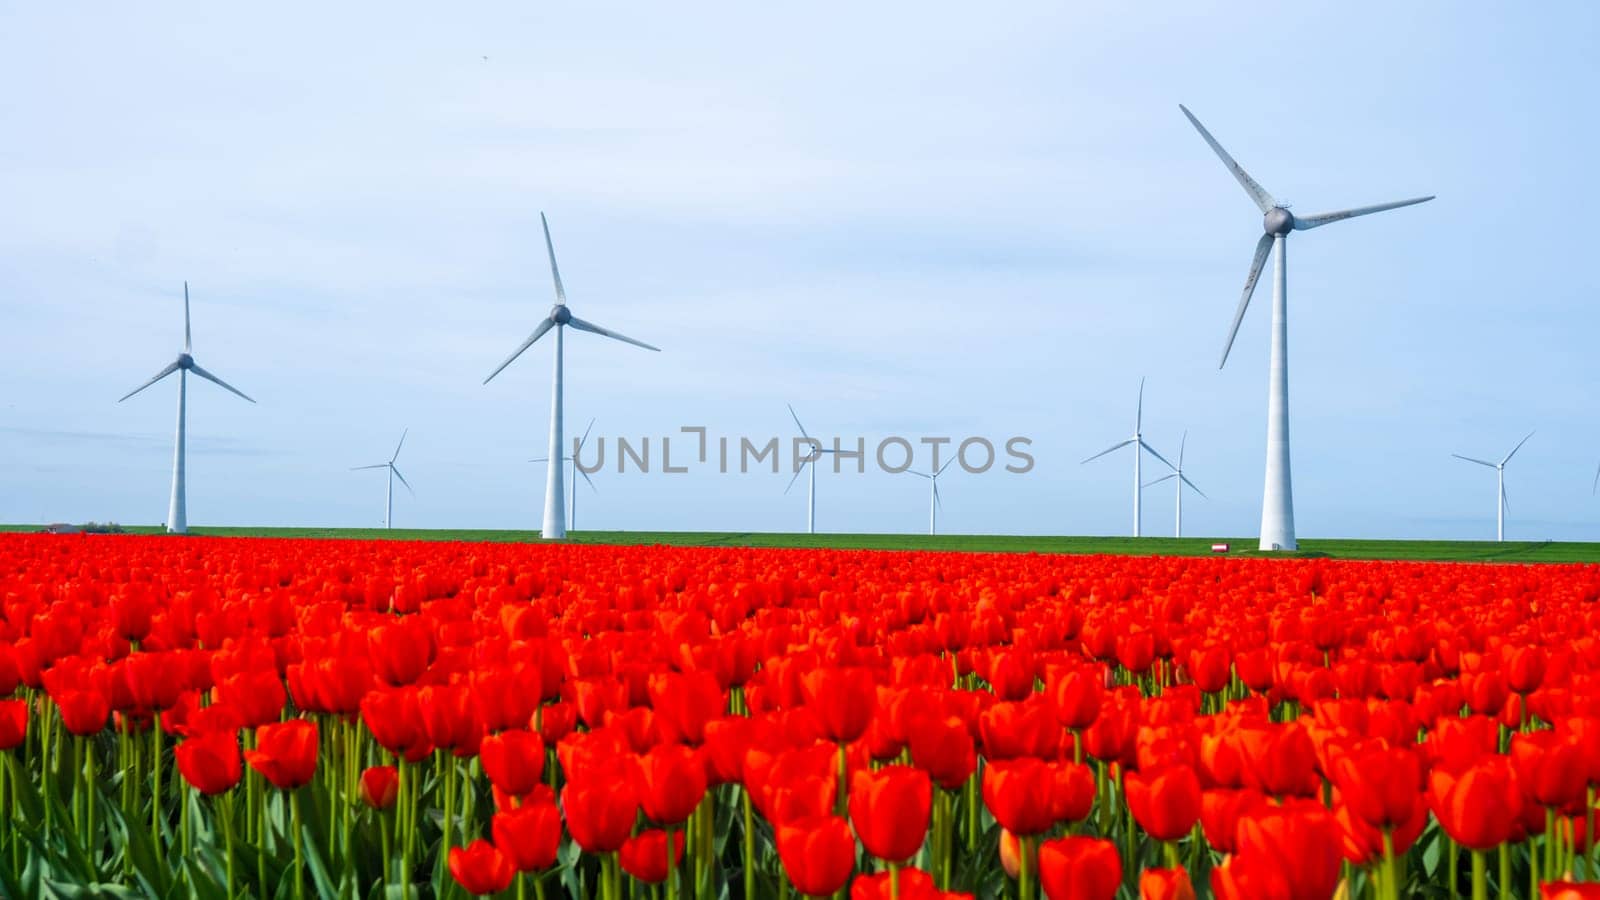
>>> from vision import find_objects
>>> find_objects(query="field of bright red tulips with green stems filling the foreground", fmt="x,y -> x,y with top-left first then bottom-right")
0,533 -> 1600,900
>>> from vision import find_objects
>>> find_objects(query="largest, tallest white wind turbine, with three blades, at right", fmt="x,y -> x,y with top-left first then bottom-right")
1178,104 -> 1434,549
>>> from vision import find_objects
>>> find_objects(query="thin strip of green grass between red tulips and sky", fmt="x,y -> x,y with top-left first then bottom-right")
0,525 -> 1600,562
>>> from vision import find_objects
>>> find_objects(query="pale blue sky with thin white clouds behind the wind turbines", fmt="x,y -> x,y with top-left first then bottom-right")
0,2 -> 1600,540
